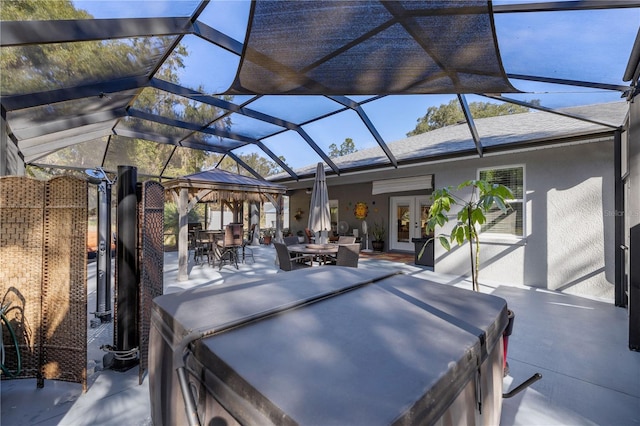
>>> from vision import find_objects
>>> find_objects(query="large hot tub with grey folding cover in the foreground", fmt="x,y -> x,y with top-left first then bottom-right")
149,266 -> 507,426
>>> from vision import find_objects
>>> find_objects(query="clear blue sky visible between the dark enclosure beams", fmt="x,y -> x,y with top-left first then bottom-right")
74,0 -> 640,168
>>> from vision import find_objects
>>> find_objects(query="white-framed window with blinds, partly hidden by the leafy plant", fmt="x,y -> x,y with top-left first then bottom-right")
478,166 -> 525,237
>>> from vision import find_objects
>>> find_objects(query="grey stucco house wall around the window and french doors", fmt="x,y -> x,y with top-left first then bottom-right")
300,139 -> 615,300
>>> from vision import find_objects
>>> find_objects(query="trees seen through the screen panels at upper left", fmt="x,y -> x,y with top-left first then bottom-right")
5,0 -> 239,180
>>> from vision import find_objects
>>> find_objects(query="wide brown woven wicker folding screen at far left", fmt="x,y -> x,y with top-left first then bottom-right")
0,176 -> 87,388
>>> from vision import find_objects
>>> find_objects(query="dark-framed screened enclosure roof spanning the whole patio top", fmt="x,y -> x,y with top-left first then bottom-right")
0,0 -> 640,182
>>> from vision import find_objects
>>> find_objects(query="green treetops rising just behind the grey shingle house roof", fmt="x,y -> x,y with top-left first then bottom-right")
407,99 -> 540,136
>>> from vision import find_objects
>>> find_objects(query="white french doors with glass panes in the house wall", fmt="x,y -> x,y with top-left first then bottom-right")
389,196 -> 430,251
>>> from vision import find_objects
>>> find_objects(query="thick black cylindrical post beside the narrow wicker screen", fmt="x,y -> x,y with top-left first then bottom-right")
114,166 -> 139,370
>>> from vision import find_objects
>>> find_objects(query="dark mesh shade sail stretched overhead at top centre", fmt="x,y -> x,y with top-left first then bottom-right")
231,0 -> 517,95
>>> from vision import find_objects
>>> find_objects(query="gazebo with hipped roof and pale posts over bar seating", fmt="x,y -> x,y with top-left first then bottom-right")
163,169 -> 286,281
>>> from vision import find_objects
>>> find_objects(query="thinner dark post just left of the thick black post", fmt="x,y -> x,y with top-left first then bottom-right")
96,180 -> 112,323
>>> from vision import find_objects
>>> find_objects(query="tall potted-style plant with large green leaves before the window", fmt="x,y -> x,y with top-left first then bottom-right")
419,180 -> 513,291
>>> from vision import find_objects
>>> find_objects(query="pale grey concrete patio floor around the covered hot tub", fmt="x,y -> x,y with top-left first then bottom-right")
0,246 -> 640,426
